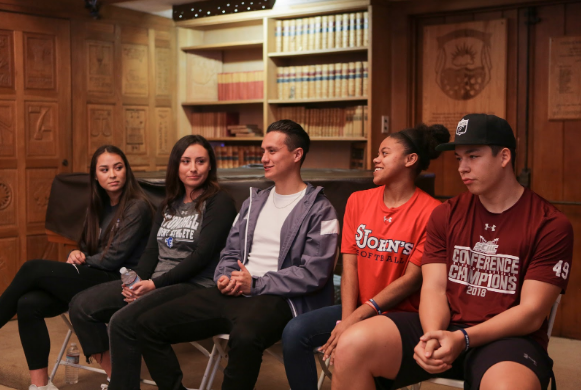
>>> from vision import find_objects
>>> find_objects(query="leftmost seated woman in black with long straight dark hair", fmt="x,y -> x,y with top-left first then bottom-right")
0,145 -> 153,390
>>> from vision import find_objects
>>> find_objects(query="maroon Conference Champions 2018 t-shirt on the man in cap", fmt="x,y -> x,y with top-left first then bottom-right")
422,189 -> 573,349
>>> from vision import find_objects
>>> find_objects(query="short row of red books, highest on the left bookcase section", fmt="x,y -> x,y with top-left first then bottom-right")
218,70 -> 264,100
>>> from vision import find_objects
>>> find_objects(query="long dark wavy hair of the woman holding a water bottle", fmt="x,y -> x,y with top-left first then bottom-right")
160,135 -> 220,214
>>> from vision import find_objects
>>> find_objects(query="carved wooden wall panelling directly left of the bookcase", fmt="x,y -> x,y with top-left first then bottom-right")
72,18 -> 176,172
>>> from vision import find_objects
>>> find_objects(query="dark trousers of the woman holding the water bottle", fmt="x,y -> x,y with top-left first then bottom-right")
69,281 -> 203,390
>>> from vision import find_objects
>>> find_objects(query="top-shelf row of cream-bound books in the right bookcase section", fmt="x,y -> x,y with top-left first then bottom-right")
275,12 -> 369,53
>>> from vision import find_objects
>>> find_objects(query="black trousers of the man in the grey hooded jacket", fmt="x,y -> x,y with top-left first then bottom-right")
137,287 -> 292,390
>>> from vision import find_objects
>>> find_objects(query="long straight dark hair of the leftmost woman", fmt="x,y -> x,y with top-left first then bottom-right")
81,145 -> 153,255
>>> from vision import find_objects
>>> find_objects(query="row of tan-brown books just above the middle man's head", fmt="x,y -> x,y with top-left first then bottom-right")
277,106 -> 368,137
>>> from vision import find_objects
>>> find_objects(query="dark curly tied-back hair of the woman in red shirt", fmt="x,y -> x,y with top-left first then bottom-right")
389,123 -> 450,176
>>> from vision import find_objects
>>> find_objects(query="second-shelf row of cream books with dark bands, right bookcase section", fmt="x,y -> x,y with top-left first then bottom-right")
276,61 -> 369,100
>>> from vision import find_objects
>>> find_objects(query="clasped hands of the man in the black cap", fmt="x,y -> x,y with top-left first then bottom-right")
414,330 -> 466,374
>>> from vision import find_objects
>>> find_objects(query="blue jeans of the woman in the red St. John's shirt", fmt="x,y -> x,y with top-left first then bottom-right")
282,305 -> 341,390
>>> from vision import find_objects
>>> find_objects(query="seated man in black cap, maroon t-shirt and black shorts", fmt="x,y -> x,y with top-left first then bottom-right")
333,114 -> 573,390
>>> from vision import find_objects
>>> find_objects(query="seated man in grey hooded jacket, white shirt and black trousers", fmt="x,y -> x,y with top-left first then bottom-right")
137,120 -> 339,390
